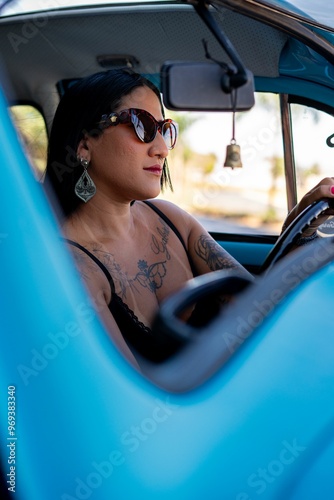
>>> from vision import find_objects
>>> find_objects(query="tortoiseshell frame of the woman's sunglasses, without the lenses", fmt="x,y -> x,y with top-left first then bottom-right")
98,108 -> 179,149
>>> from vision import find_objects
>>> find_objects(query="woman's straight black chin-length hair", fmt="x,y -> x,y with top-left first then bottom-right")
44,68 -> 172,217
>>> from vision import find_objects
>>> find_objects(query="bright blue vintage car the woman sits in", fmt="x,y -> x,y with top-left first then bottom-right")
0,0 -> 334,500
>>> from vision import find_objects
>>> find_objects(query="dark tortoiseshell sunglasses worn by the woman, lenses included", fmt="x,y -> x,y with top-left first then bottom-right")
99,108 -> 178,149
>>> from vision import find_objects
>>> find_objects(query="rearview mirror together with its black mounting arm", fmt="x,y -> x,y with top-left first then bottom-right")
160,0 -> 255,112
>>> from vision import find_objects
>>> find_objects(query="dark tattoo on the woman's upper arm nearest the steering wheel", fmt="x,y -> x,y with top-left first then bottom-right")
194,234 -> 239,271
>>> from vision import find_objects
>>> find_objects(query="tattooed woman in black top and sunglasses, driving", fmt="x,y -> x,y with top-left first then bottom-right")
45,69 -> 334,361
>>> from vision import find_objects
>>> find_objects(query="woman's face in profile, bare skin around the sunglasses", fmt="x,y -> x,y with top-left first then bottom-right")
78,87 -> 168,202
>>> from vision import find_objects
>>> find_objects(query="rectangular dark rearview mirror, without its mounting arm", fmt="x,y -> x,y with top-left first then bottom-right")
160,62 -> 255,111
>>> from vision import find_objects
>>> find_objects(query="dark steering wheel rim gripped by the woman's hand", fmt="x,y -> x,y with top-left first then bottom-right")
260,198 -> 334,274
